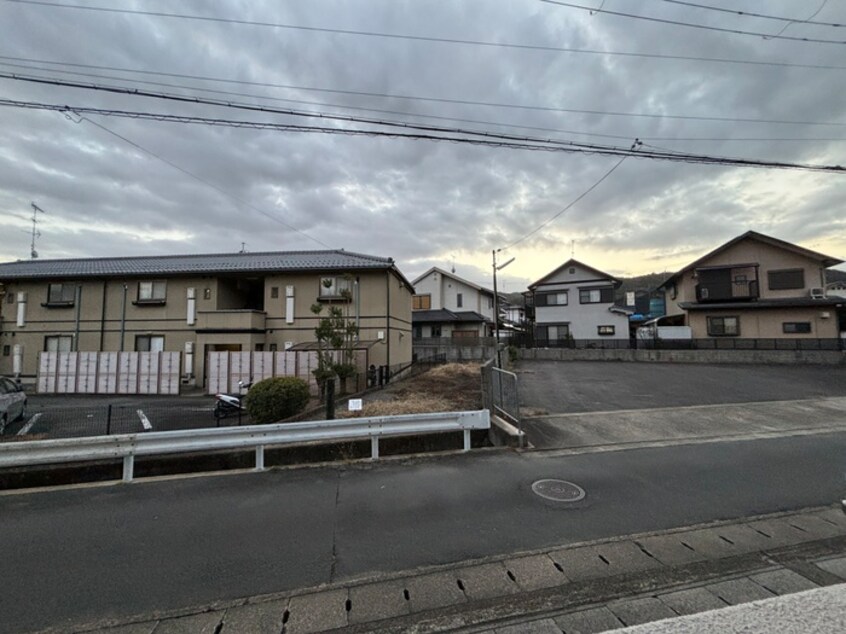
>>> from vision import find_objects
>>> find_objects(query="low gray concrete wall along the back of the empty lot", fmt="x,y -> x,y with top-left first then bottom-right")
517,348 -> 846,365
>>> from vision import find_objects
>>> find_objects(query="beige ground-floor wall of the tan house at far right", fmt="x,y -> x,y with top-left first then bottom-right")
688,306 -> 840,339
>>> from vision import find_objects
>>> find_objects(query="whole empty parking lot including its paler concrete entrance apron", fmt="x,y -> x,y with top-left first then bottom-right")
517,361 -> 846,449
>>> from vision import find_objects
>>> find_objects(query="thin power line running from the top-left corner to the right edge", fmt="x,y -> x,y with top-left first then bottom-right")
4,0 -> 846,70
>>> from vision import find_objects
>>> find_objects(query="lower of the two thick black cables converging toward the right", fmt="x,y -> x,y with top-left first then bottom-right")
0,99 -> 846,174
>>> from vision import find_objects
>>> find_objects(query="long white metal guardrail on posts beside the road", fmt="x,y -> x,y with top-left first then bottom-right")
0,410 -> 490,482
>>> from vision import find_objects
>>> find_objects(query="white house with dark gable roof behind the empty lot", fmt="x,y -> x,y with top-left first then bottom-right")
529,259 -> 629,346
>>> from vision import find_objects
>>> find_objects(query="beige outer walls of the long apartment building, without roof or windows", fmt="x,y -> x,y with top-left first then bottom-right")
0,271 -> 411,377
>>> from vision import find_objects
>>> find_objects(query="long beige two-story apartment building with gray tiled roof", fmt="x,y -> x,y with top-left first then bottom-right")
0,250 -> 412,384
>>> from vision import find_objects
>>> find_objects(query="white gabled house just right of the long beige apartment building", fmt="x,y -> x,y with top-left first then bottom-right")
412,267 -> 494,338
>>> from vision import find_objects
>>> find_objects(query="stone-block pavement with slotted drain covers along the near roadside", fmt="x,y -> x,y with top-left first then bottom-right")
71,507 -> 846,634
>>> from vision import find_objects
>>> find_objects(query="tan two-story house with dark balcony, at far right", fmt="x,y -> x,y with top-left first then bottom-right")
661,231 -> 846,339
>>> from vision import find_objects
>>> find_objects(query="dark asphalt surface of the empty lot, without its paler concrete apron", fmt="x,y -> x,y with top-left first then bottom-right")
517,361 -> 846,414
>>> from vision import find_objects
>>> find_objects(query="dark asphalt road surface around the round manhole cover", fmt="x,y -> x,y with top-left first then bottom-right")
0,432 -> 846,632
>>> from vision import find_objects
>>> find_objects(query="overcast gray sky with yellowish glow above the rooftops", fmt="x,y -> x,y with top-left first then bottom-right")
0,0 -> 846,291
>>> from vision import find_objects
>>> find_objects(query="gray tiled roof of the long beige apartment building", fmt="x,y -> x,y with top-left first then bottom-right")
0,249 -> 406,281
